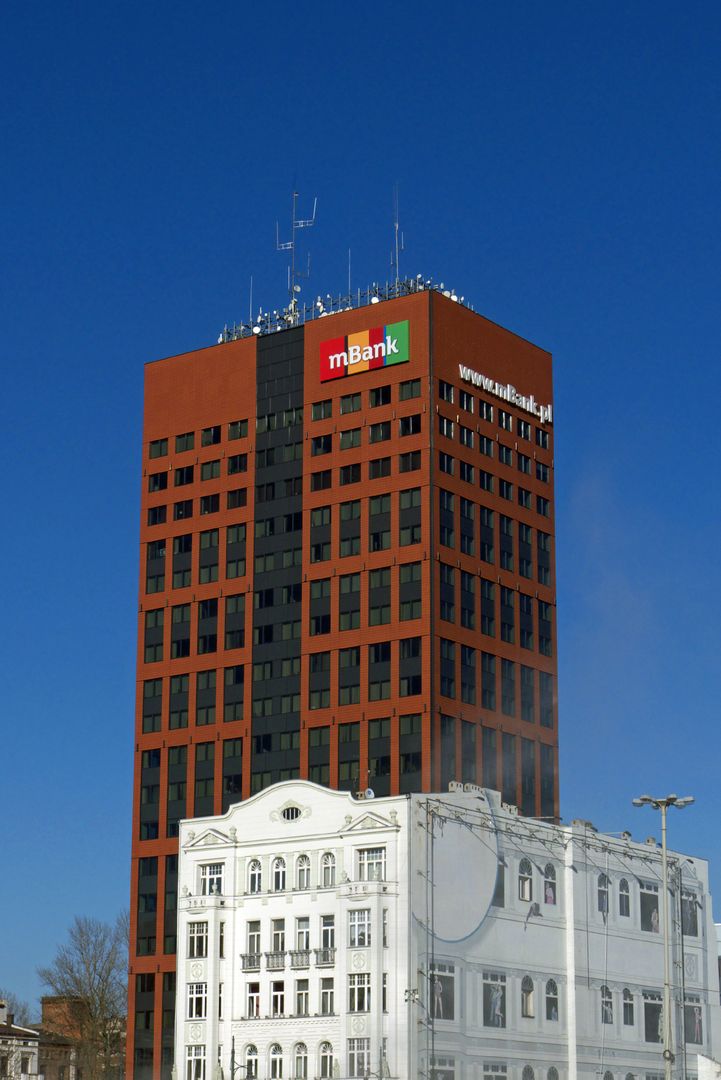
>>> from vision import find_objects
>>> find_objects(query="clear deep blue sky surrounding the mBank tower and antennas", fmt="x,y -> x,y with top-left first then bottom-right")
0,0 -> 721,1000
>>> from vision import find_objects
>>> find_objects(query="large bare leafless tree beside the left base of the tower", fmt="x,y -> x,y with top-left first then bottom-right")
38,915 -> 127,1080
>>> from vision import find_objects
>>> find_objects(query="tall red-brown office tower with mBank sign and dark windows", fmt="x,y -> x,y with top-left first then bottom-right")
128,286 -> 558,1080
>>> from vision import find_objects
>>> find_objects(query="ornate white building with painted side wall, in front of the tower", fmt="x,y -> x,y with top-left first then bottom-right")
175,781 -> 720,1080
